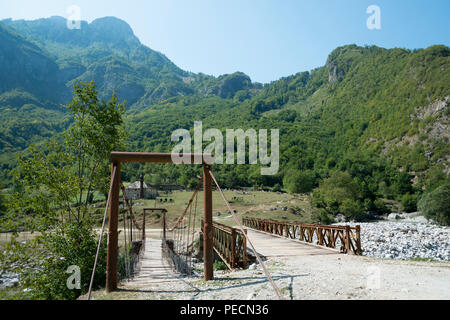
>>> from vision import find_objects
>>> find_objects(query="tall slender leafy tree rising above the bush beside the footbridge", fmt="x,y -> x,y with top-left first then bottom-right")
65,81 -> 125,221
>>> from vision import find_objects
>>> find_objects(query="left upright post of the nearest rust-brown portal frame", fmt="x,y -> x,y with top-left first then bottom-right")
106,162 -> 120,292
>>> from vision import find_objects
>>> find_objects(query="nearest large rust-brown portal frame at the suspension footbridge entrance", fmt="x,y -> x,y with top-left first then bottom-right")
106,152 -> 214,292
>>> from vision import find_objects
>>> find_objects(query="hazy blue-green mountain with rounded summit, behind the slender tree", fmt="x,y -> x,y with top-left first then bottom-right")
0,17 -> 257,184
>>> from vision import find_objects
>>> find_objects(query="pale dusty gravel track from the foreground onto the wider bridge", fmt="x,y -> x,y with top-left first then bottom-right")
87,231 -> 450,300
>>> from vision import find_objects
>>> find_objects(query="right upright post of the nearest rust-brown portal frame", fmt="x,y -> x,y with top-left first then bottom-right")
203,164 -> 214,281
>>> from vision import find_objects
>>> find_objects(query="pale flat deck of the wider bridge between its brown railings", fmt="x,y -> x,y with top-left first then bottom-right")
244,227 -> 339,258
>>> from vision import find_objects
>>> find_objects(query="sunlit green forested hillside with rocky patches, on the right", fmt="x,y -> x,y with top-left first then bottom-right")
127,45 -> 450,197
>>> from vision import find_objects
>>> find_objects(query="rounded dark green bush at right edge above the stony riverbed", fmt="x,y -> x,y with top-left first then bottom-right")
418,184 -> 450,226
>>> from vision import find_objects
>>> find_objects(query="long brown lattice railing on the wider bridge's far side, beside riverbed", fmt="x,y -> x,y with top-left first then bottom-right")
242,217 -> 362,255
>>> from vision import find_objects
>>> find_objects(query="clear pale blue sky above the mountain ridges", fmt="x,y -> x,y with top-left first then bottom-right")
0,0 -> 450,82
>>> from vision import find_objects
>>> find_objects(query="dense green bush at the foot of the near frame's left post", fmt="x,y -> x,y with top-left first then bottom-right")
8,223 -> 106,300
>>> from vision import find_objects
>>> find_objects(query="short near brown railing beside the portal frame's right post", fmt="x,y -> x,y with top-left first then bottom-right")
205,222 -> 247,270
